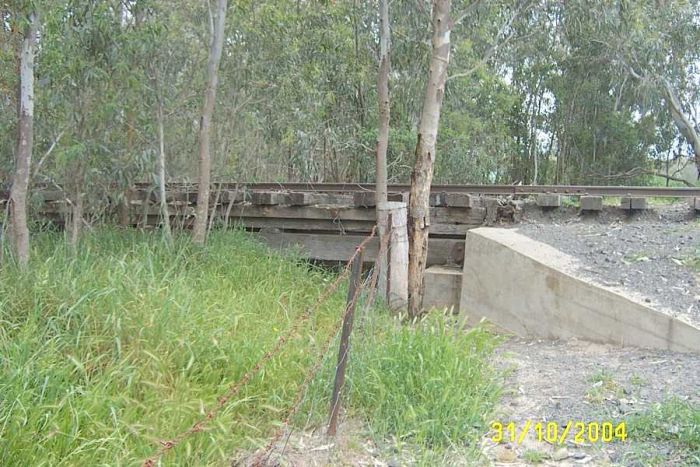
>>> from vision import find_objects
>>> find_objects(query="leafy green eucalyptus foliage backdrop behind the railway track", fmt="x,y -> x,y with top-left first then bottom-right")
0,0 -> 700,190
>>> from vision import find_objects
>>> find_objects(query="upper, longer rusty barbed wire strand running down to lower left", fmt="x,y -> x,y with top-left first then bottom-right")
142,225 -> 377,467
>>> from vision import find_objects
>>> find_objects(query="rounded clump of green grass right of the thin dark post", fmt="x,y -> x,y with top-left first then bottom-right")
304,313 -> 501,460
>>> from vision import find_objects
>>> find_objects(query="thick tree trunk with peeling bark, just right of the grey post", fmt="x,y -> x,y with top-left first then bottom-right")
408,0 -> 452,316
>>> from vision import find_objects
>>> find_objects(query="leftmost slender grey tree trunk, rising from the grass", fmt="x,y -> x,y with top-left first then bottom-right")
10,13 -> 38,269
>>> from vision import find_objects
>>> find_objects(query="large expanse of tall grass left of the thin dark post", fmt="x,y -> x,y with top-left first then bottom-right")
0,232 -> 344,465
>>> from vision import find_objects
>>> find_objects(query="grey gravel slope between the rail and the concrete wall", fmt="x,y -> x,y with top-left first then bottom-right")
515,203 -> 700,325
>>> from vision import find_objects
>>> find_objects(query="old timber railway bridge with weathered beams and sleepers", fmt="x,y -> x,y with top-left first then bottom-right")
0,183 -> 700,266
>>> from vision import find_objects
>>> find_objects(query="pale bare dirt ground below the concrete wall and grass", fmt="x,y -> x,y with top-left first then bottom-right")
239,338 -> 700,467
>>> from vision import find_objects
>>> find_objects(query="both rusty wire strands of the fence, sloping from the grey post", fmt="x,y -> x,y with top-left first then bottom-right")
142,226 -> 386,467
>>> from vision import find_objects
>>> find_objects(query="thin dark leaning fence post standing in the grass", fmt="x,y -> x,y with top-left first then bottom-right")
328,249 -> 363,436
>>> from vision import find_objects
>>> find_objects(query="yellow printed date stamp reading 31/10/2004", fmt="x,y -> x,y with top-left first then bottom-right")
491,420 -> 627,444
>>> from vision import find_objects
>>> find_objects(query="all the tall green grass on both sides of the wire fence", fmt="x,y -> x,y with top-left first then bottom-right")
0,231 -> 499,466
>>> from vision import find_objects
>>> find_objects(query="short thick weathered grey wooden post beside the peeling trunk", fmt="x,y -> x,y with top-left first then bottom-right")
377,202 -> 408,311
